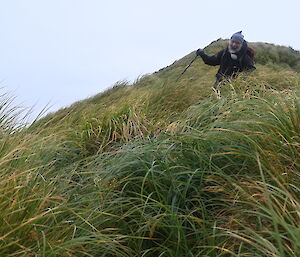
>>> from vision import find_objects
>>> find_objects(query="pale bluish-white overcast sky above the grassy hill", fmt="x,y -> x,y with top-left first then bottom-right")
0,0 -> 300,116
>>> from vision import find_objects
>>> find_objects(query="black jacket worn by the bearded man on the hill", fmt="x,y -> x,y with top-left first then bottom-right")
201,41 -> 256,81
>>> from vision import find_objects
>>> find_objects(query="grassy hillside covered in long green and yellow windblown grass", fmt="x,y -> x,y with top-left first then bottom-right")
0,40 -> 300,257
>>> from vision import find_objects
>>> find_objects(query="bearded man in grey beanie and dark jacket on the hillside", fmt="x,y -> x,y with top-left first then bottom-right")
197,31 -> 256,90
